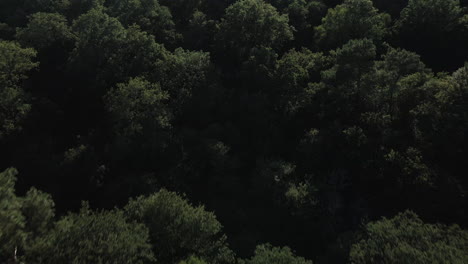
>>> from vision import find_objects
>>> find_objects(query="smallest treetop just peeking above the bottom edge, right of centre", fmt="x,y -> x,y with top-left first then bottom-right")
245,244 -> 312,264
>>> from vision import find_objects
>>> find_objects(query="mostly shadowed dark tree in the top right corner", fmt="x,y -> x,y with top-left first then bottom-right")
395,0 -> 468,71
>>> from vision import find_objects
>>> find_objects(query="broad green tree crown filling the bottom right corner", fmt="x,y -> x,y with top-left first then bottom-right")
350,211 -> 468,263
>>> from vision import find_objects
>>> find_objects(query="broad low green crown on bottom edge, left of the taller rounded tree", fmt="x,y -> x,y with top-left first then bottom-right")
35,205 -> 155,264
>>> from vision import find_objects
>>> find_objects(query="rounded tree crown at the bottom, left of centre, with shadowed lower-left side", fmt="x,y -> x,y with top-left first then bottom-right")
125,189 -> 233,263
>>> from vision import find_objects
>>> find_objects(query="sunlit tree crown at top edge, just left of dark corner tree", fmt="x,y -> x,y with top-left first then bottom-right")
315,0 -> 390,49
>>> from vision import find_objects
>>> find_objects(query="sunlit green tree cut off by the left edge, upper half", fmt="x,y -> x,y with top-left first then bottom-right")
0,41 -> 38,139
